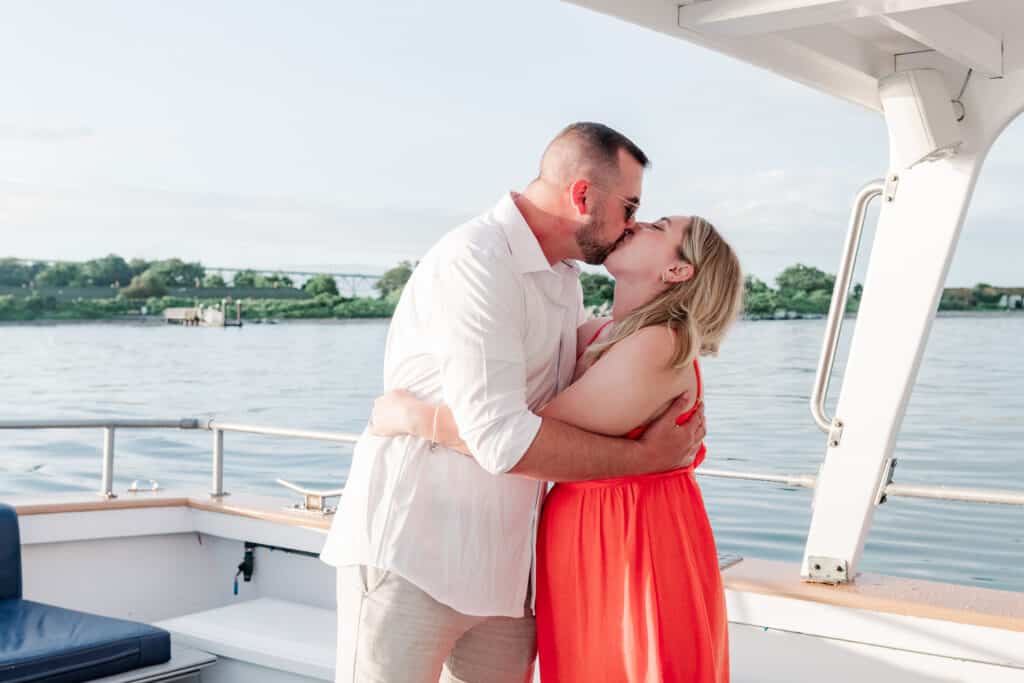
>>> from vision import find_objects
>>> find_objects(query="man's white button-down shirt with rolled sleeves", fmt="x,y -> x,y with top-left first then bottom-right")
321,195 -> 584,616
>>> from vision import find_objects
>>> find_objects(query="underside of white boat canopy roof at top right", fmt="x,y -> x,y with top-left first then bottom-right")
568,0 -> 1024,111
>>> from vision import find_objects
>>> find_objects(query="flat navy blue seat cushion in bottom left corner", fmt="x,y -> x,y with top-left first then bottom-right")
0,600 -> 171,683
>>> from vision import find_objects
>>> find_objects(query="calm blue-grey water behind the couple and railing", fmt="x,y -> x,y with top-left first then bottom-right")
0,315 -> 1024,591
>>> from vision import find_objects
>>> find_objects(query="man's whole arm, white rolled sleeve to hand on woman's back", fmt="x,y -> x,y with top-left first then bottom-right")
431,247 -> 703,481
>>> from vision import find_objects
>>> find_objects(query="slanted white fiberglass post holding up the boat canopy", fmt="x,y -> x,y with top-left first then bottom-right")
801,65 -> 1024,583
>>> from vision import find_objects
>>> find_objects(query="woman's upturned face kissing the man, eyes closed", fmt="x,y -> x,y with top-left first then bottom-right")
604,216 -> 690,282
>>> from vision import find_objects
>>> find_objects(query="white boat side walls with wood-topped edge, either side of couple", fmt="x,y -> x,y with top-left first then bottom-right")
11,490 -> 1024,683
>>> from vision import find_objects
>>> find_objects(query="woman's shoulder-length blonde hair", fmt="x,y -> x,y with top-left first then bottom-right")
587,216 -> 743,369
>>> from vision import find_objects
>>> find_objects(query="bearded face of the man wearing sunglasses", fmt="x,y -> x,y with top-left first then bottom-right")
575,150 -> 643,265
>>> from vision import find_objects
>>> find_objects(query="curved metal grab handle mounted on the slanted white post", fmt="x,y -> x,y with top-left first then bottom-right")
811,178 -> 885,438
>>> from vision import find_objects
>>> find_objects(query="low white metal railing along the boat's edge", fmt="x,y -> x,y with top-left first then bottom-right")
0,418 -> 1024,506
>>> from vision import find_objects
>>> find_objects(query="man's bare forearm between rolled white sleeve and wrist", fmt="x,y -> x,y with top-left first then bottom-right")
509,418 -> 657,481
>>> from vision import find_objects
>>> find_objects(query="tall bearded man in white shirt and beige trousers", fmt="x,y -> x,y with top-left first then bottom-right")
321,123 -> 703,683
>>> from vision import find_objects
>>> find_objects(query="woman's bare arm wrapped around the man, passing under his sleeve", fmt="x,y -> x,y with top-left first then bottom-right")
371,327 -> 698,448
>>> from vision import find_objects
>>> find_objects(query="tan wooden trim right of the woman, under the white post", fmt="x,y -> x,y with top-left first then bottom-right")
722,558 -> 1024,632
